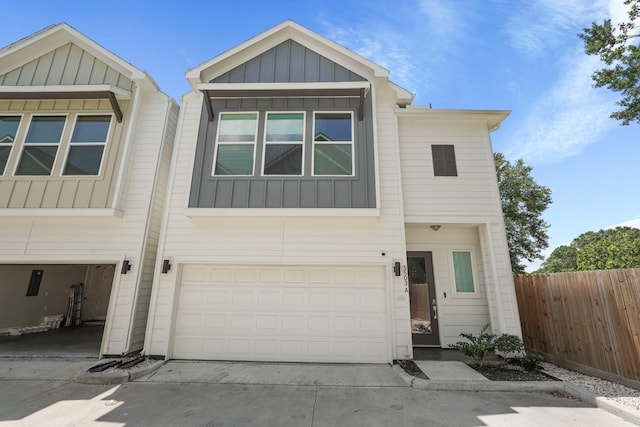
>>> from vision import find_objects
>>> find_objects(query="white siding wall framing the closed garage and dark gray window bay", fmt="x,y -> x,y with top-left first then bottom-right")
145,83 -> 411,358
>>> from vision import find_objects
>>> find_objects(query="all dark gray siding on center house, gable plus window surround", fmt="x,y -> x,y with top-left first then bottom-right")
189,40 -> 377,208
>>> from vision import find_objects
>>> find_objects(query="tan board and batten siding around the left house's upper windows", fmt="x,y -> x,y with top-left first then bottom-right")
0,100 -> 132,209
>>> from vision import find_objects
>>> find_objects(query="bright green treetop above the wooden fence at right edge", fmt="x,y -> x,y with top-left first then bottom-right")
574,227 -> 640,270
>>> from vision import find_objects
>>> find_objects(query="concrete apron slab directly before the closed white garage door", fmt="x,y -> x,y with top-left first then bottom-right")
141,361 -> 408,387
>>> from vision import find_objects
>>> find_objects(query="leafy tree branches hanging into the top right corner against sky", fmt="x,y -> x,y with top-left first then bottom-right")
579,0 -> 640,125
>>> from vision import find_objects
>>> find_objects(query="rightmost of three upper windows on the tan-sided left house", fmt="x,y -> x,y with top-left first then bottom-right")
63,116 -> 111,175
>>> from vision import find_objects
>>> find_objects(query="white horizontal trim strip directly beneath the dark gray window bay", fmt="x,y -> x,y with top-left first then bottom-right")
183,208 -> 380,218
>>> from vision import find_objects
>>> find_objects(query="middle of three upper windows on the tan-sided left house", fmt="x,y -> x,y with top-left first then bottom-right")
16,116 -> 66,175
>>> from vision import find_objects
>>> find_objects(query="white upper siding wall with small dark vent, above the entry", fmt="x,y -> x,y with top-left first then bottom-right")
399,118 -> 500,223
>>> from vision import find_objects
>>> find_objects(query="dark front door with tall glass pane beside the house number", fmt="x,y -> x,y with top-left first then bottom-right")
407,252 -> 440,347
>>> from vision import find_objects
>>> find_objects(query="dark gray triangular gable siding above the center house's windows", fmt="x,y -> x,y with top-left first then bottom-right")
211,40 -> 365,83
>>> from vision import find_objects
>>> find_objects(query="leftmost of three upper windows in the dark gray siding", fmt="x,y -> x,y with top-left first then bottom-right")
213,113 -> 258,175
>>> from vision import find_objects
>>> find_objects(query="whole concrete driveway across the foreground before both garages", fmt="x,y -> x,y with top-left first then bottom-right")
0,360 -> 632,427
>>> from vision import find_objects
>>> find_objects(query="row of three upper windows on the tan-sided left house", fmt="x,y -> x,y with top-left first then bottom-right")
0,114 -> 111,176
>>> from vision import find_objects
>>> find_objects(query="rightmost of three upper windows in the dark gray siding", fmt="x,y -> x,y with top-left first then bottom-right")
313,113 -> 353,176
